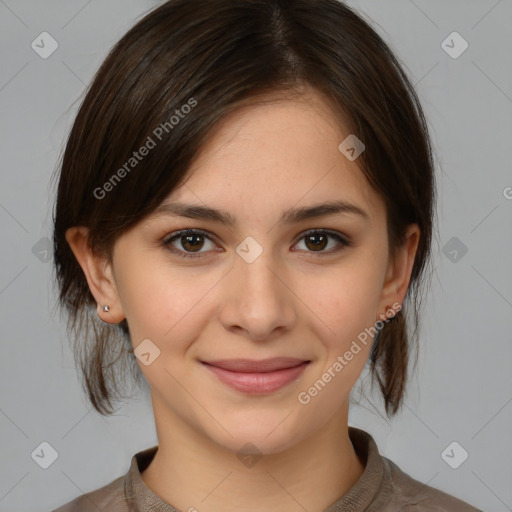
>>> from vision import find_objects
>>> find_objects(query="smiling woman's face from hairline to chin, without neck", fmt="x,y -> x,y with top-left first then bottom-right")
75,90 -> 416,453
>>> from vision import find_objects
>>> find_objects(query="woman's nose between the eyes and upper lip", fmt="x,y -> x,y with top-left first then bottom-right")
220,246 -> 297,341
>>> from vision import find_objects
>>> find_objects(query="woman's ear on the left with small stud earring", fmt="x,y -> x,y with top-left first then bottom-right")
66,226 -> 125,324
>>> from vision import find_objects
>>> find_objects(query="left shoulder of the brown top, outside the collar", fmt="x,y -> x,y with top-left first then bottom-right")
52,476 -> 131,512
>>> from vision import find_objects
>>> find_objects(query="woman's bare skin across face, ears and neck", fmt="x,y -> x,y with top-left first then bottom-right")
66,92 -> 419,512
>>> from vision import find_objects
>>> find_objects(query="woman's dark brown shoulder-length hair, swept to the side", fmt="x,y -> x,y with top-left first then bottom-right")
54,0 -> 435,415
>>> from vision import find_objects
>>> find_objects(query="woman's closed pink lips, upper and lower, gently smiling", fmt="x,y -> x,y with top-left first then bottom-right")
202,357 -> 311,394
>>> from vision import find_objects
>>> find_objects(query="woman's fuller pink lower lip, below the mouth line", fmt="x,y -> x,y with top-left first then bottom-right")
203,361 -> 309,395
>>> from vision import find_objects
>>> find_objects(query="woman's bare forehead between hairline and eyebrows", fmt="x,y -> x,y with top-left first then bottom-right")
165,89 -> 384,221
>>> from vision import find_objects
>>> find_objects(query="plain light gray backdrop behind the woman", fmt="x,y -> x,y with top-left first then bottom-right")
0,0 -> 512,512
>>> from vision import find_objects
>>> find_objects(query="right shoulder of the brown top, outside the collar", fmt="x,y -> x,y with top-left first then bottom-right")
382,457 -> 482,512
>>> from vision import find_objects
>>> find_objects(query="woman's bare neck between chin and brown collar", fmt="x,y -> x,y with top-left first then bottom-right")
142,394 -> 364,512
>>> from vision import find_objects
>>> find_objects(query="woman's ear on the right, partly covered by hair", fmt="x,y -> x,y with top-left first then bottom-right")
377,224 -> 420,319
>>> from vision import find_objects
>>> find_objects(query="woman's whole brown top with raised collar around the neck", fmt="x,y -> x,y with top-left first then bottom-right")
53,427 -> 482,512
